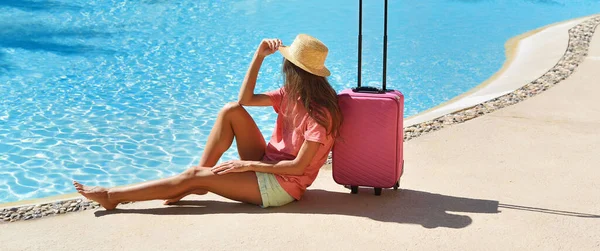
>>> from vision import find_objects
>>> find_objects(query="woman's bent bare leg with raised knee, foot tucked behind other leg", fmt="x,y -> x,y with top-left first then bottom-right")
164,102 -> 266,205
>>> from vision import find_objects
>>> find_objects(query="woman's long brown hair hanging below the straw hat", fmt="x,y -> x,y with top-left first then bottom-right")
282,58 -> 342,137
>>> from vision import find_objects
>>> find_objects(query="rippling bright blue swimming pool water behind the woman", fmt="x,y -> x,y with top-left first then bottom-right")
0,0 -> 600,203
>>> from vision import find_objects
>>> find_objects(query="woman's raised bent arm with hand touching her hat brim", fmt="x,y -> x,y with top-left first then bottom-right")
238,39 -> 281,106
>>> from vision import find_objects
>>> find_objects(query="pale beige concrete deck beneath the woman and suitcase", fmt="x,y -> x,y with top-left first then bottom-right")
0,21 -> 600,250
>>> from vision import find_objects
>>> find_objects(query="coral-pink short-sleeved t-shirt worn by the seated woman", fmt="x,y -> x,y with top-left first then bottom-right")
264,88 -> 334,200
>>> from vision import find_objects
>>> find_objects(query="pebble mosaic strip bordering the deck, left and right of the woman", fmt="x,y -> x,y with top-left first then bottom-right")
0,16 -> 600,222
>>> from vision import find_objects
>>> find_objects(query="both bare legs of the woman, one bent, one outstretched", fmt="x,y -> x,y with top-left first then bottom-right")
73,103 -> 266,210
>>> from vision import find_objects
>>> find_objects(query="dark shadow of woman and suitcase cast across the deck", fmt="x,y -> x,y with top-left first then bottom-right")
95,189 -> 499,228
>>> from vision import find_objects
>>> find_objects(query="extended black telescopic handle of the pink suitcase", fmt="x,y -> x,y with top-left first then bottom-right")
352,0 -> 388,93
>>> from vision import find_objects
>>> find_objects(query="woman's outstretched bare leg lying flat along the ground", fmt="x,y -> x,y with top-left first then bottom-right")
73,167 -> 262,210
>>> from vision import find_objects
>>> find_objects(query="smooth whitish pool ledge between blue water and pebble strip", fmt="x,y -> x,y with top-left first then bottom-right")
404,15 -> 596,127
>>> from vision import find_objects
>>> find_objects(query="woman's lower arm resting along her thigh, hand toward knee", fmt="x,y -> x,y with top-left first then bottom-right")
212,141 -> 321,175
